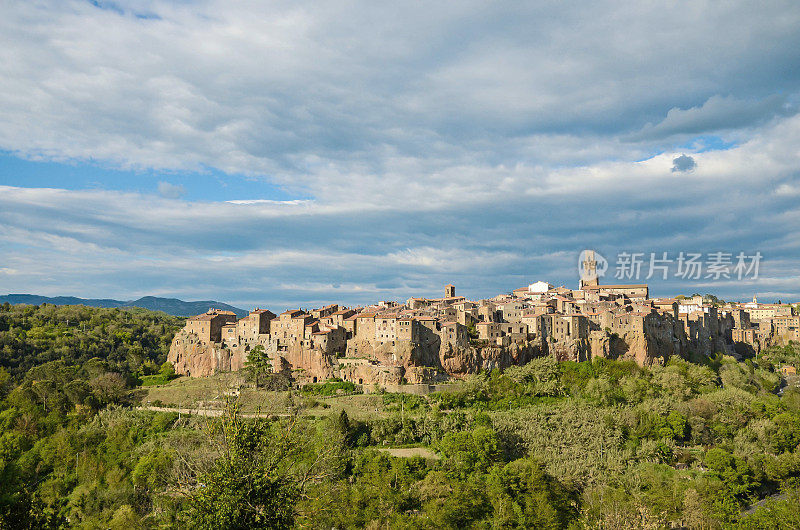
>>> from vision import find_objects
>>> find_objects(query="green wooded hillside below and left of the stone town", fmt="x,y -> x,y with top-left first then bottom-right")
0,300 -> 800,529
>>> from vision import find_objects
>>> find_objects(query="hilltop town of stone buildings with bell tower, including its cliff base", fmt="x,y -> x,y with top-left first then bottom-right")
168,253 -> 800,385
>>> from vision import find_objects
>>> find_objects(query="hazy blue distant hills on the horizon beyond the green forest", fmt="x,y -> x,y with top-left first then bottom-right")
0,294 -> 247,317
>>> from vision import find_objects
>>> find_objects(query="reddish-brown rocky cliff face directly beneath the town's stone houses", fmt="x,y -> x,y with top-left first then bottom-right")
168,319 -> 700,385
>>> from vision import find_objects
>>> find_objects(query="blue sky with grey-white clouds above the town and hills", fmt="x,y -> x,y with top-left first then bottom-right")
0,0 -> 800,311
